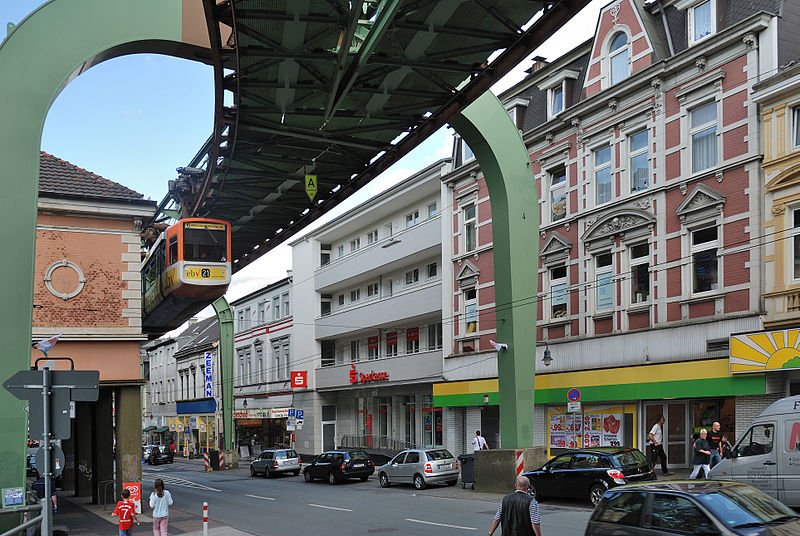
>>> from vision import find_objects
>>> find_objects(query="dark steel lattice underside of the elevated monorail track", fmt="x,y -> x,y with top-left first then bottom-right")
184,0 -> 590,271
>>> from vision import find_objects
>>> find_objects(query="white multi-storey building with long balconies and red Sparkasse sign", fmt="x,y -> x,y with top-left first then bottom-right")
290,160 -> 450,453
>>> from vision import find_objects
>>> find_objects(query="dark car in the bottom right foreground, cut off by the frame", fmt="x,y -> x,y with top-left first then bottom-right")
585,480 -> 800,536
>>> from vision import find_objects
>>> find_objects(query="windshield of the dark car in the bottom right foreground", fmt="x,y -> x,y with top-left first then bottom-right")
697,486 -> 797,528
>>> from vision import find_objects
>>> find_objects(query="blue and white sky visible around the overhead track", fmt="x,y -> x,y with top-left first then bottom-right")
0,0 -> 610,317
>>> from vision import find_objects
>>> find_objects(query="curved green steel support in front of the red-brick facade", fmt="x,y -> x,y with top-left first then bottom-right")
451,91 -> 539,448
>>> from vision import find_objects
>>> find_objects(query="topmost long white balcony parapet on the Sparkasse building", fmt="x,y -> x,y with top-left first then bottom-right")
314,216 -> 442,292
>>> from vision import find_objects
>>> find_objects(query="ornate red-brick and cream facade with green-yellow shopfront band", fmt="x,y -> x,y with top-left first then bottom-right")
434,0 -> 800,467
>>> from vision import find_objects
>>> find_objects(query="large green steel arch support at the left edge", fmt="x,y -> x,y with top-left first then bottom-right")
0,0 -> 183,527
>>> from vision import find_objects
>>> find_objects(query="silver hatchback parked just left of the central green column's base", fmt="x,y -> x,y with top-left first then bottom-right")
378,449 -> 458,489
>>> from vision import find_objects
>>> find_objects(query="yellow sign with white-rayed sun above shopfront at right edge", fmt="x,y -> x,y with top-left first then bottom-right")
730,329 -> 800,374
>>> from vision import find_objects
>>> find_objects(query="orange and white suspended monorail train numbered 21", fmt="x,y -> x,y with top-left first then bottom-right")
142,218 -> 231,334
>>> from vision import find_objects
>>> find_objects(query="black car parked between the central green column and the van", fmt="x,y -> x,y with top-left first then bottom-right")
524,447 -> 656,505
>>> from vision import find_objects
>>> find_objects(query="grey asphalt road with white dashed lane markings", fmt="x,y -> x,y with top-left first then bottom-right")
142,461 -> 591,536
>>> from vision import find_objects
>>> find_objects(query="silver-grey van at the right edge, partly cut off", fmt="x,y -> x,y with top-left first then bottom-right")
709,396 -> 800,507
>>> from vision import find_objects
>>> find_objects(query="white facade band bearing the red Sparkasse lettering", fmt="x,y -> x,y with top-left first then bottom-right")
314,350 -> 442,391
